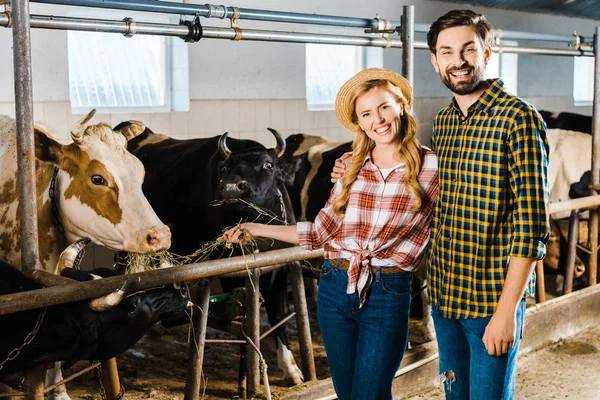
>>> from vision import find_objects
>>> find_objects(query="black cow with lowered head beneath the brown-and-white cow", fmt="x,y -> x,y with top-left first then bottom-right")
0,260 -> 188,380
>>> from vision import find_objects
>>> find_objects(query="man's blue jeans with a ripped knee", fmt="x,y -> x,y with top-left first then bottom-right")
431,299 -> 525,400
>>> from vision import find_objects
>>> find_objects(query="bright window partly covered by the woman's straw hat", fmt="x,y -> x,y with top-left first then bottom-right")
306,43 -> 383,111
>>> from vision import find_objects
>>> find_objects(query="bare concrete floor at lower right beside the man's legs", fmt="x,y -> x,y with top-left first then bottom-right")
409,324 -> 600,400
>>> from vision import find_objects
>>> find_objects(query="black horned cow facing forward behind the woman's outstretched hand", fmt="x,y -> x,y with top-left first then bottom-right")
118,122 -> 303,384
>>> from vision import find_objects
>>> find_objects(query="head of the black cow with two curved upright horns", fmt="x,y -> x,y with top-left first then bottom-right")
217,128 -> 286,206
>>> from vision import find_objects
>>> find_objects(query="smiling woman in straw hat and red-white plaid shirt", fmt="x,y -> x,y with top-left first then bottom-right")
224,68 -> 438,400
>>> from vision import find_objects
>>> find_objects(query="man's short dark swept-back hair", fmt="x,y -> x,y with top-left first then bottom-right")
427,10 -> 494,54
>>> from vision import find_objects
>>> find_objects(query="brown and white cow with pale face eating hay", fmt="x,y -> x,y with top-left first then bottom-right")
0,111 -> 171,400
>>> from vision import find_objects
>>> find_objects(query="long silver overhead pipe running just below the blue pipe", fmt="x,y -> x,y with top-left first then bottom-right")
0,14 -> 594,57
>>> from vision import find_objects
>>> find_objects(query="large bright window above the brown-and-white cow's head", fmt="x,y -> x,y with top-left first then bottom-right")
68,11 -> 189,113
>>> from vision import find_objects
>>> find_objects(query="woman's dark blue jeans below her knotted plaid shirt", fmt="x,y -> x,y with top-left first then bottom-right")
317,260 -> 412,400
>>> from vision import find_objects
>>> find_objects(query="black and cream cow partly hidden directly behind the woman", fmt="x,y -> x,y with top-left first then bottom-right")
282,133 -> 435,343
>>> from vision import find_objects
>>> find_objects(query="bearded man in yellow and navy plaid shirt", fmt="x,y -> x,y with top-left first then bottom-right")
427,10 -> 550,400
